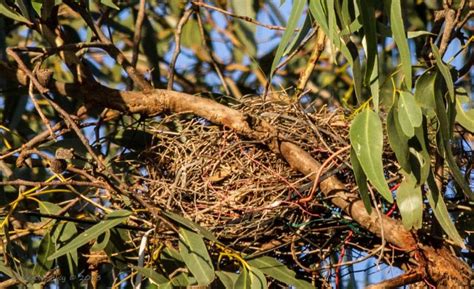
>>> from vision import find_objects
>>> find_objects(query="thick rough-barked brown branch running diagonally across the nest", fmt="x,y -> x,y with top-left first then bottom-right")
0,61 -> 471,288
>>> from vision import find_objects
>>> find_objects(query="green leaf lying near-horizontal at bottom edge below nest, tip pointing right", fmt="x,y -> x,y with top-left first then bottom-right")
246,256 -> 314,289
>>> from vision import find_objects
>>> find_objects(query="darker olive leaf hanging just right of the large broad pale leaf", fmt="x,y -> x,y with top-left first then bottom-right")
387,104 -> 411,172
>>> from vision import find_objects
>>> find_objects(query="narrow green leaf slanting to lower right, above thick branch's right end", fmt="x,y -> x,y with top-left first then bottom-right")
426,172 -> 466,248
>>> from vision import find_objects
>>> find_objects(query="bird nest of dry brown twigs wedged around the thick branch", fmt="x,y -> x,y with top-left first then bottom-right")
137,98 -> 366,251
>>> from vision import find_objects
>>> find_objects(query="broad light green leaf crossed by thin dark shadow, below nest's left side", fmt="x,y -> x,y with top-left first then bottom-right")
179,227 -> 215,285
